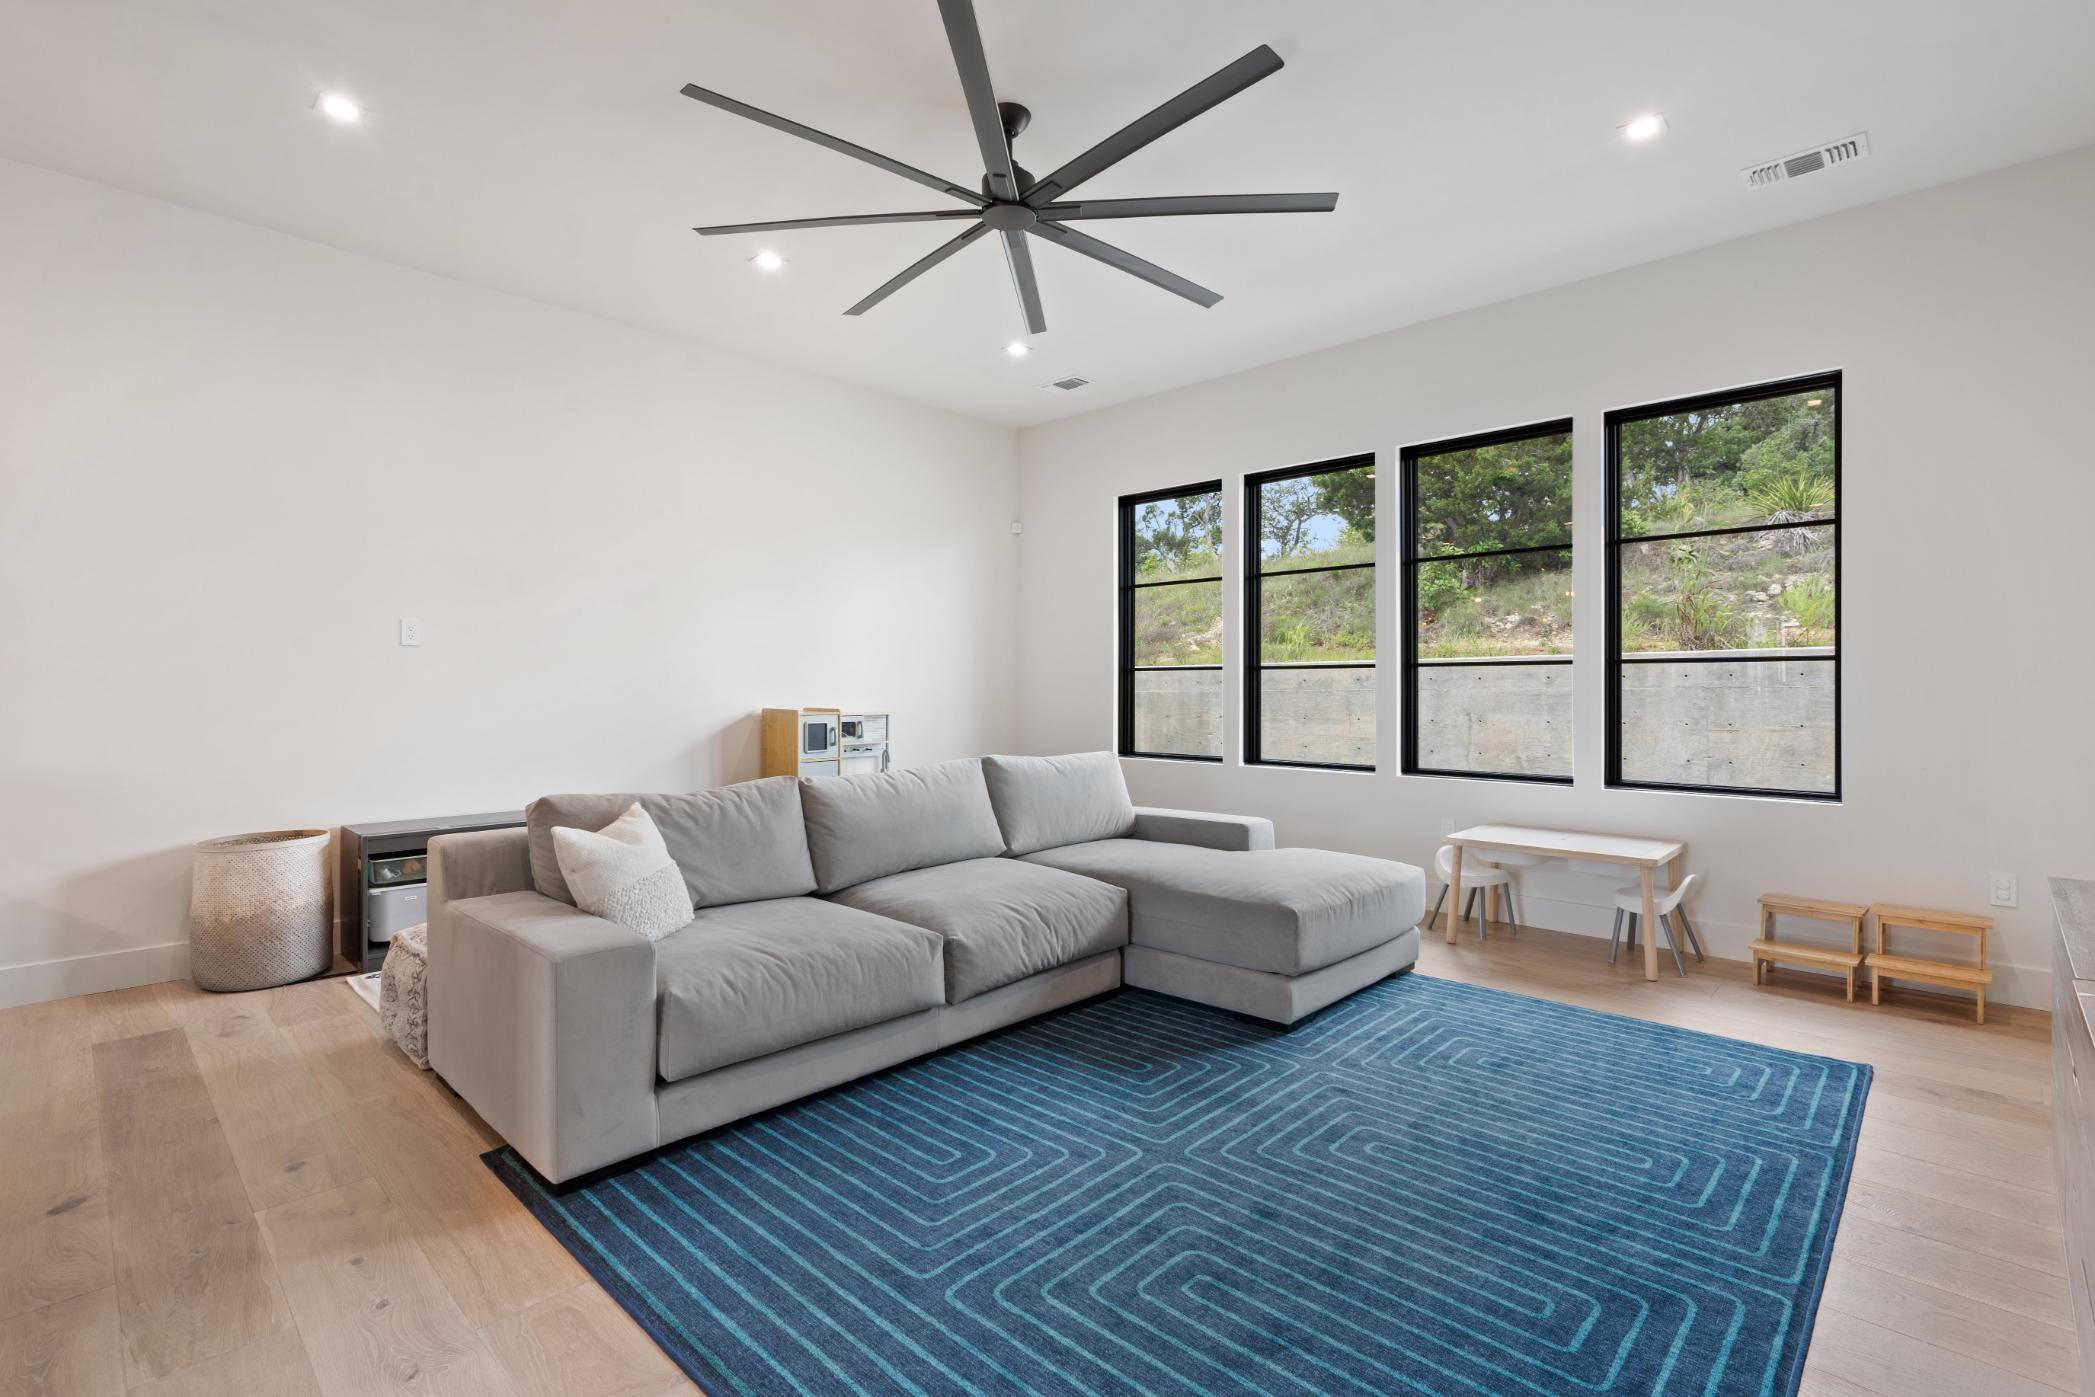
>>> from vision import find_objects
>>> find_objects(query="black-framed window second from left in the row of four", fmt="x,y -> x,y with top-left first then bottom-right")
1244,457 -> 1374,771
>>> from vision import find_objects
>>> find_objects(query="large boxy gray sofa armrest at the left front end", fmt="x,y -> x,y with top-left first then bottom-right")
429,892 -> 658,1183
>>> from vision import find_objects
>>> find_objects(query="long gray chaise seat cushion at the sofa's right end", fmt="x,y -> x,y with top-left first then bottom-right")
1024,840 -> 1427,976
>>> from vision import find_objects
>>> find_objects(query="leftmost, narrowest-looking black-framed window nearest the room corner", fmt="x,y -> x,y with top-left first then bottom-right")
1121,480 -> 1221,762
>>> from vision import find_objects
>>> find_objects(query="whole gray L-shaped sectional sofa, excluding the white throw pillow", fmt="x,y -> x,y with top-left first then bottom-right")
429,752 -> 1425,1183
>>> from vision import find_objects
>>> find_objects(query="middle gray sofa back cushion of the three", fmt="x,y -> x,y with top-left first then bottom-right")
800,758 -> 1004,892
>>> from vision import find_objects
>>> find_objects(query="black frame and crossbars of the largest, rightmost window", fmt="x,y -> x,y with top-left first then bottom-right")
1605,369 -> 1848,804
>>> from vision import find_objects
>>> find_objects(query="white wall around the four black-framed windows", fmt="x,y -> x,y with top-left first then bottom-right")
1018,151 -> 2095,1003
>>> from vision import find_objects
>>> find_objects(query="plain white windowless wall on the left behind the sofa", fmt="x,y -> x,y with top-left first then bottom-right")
0,161 -> 1016,1003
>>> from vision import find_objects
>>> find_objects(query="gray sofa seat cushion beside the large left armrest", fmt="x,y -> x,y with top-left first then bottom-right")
656,896 -> 945,1081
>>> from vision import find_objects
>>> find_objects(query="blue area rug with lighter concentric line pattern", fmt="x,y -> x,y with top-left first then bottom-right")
486,974 -> 1869,1397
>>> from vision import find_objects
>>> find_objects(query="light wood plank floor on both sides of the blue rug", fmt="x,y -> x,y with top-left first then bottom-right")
0,928 -> 2076,1397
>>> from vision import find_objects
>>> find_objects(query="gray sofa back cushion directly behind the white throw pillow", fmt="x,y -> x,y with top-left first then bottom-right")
524,777 -> 815,907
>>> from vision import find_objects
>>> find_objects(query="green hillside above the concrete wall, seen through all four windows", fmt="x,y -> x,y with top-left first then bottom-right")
1135,392 -> 1837,664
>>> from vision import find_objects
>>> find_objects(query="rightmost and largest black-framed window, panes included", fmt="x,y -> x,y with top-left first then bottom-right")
1607,373 -> 1839,800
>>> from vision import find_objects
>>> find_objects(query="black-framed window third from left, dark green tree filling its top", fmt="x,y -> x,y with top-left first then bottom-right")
1404,421 -> 1571,781
